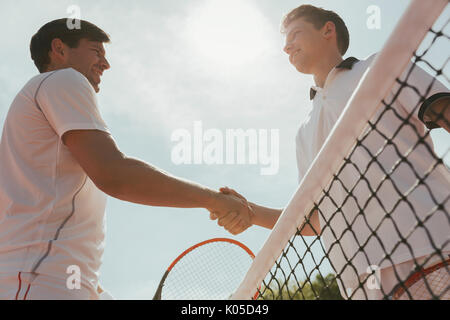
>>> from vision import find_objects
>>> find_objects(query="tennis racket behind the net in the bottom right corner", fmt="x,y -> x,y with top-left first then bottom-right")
392,259 -> 450,300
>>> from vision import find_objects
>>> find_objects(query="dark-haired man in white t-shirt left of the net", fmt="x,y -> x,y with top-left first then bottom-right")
0,19 -> 252,299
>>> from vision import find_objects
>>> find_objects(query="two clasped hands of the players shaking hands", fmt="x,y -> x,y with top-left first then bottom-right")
208,187 -> 255,235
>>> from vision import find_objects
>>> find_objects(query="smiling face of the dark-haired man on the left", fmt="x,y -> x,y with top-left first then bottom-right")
67,39 -> 110,92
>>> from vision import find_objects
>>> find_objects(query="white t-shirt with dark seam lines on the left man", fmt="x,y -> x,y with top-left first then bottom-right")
0,68 -> 109,292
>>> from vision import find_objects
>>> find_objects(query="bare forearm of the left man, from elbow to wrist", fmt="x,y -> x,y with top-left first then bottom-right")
103,157 -> 216,209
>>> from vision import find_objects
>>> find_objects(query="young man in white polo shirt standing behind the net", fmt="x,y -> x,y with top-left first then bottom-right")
215,5 -> 450,299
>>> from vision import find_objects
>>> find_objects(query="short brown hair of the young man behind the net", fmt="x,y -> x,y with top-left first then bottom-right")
281,4 -> 350,55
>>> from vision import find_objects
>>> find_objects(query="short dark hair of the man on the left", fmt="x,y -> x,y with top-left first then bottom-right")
30,18 -> 110,73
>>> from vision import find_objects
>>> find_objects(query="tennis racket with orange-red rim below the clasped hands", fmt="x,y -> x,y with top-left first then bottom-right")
153,238 -> 258,300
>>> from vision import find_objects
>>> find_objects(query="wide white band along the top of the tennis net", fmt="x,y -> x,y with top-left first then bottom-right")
232,0 -> 448,300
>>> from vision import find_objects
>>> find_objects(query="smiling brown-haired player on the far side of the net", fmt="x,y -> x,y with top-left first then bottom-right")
215,5 -> 450,299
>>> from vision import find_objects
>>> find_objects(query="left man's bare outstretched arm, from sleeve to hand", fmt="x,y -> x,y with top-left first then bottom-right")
62,130 -> 250,222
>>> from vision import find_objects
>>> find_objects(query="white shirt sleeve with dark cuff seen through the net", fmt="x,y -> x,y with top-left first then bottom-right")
393,62 -> 449,129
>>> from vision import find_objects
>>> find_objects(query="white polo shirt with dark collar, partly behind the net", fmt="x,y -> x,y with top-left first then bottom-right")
296,55 -> 450,289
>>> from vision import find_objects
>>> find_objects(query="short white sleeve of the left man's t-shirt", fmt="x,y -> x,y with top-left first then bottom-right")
35,68 -> 109,137
